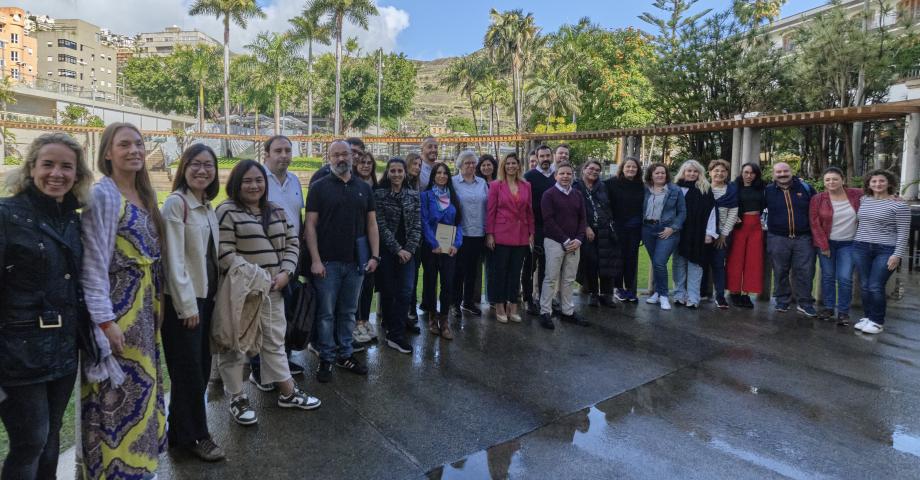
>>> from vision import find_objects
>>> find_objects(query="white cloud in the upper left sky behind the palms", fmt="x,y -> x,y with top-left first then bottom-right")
7,0 -> 409,52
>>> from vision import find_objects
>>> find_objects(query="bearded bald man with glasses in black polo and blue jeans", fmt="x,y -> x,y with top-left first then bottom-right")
304,140 -> 380,383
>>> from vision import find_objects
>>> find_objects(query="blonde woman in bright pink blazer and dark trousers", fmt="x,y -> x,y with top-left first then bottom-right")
486,153 -> 534,323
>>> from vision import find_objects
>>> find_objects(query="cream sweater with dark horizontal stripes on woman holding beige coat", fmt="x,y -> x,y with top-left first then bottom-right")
216,200 -> 300,277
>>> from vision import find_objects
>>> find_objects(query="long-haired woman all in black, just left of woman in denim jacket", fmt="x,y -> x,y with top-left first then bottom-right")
604,157 -> 645,303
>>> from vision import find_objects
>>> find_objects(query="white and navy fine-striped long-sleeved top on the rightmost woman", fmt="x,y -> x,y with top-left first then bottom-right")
854,196 -> 910,259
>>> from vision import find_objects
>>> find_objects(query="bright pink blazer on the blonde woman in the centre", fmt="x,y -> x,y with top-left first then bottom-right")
486,180 -> 534,247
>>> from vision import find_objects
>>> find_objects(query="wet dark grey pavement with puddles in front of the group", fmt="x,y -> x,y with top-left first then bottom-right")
160,274 -> 920,480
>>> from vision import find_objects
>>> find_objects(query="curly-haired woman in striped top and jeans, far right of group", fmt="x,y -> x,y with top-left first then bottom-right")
853,170 -> 910,334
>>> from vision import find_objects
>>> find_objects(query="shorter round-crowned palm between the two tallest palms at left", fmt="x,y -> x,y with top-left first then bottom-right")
240,32 -> 303,135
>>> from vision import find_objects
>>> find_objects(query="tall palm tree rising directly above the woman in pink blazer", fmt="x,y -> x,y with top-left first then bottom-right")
483,8 -> 540,132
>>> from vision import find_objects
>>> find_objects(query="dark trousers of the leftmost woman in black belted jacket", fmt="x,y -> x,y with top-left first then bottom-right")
0,373 -> 75,480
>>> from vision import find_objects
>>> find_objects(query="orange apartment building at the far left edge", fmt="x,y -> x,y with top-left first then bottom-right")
0,7 -> 38,83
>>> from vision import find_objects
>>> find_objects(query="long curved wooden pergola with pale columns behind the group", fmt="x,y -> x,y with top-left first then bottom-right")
0,100 -> 920,200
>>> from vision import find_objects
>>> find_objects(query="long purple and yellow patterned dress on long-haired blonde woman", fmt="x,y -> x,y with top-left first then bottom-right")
80,200 -> 166,479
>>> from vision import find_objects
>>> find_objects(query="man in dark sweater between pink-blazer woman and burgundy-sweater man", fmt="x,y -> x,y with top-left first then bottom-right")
521,145 -> 556,315
